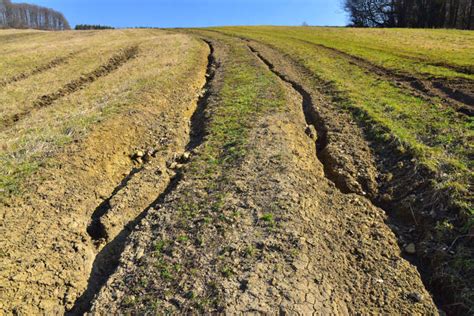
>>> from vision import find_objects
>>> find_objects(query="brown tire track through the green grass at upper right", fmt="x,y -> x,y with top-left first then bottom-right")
293,38 -> 474,116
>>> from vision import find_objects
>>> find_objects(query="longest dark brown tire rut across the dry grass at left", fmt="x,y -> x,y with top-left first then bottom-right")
2,46 -> 139,129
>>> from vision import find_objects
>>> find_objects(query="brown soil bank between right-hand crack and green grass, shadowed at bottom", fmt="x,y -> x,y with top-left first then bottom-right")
243,40 -> 472,314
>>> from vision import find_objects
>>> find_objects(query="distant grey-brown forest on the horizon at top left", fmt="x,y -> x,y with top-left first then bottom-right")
0,0 -> 71,30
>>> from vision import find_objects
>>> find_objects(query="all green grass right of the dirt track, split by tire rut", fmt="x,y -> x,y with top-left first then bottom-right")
214,27 -> 474,312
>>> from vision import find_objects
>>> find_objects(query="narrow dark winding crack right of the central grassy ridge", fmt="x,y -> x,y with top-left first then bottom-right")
243,44 -> 442,312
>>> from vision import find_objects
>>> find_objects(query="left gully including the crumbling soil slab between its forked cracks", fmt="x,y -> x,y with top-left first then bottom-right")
68,43 -> 217,315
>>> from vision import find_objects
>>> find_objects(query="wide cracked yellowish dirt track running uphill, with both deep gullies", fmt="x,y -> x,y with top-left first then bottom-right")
0,32 -> 454,315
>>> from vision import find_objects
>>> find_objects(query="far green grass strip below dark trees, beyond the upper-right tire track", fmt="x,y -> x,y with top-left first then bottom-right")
219,27 -> 474,79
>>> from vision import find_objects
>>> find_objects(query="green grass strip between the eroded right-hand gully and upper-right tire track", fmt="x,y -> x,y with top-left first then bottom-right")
217,27 -> 474,215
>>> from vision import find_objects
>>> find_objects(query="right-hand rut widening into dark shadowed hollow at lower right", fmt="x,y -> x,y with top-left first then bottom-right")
249,42 -> 470,310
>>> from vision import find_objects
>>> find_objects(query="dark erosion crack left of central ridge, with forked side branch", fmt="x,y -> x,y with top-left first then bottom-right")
66,39 -> 218,315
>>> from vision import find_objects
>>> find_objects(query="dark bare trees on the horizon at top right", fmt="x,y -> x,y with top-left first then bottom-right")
344,0 -> 474,30
